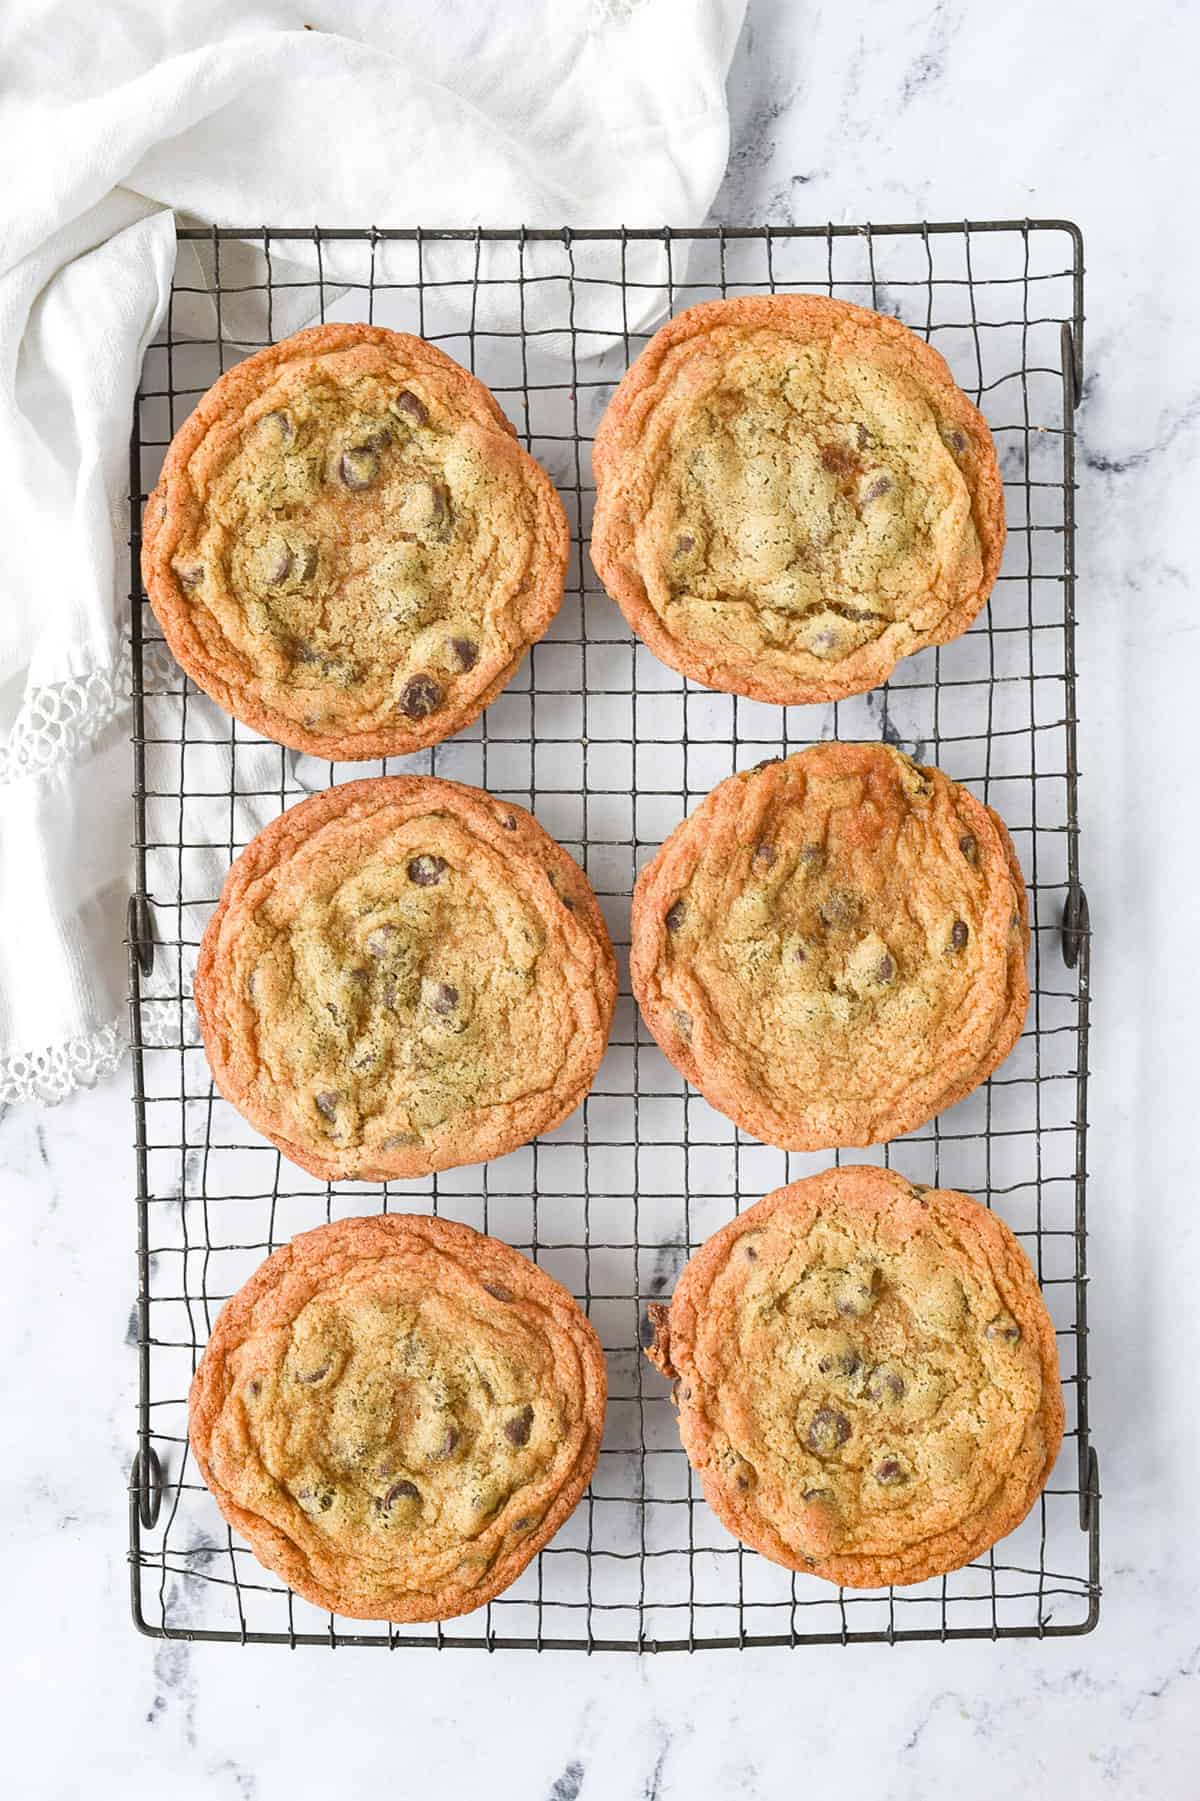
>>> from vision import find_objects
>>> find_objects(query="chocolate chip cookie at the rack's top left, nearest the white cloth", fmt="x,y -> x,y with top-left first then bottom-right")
142,324 -> 569,758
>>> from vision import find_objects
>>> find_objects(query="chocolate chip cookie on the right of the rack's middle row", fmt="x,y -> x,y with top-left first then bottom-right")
629,744 -> 1029,1151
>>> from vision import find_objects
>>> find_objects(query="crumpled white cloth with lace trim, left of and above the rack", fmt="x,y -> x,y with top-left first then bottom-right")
0,0 -> 744,1102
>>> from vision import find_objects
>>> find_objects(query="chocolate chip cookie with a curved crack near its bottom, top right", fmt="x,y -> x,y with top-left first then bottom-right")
591,294 -> 1004,704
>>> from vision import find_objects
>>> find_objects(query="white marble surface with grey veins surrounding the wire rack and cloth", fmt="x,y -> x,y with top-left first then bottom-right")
0,0 -> 1200,1801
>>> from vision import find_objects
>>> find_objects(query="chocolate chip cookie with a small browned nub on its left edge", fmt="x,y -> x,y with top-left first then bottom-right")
649,1167 -> 1063,1588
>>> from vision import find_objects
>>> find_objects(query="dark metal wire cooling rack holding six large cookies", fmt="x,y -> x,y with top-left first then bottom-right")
130,222 -> 1099,1652
